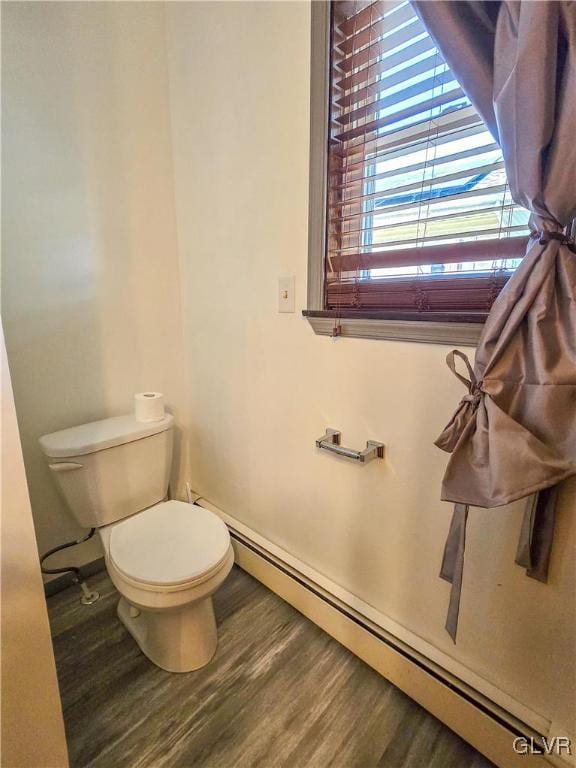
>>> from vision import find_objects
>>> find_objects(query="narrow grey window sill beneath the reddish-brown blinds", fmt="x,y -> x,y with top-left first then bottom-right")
302,310 -> 483,347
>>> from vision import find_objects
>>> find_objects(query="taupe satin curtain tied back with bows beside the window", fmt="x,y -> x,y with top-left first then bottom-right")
413,0 -> 576,640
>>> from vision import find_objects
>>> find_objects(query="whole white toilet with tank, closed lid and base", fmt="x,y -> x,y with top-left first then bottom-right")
39,414 -> 234,672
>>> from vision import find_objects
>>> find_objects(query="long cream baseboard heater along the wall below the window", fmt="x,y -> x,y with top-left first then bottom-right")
224,520 -> 567,768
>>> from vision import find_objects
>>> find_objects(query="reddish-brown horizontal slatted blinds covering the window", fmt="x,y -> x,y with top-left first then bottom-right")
325,0 -> 528,319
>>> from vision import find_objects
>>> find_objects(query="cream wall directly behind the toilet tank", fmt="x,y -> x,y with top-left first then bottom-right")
2,2 -> 183,562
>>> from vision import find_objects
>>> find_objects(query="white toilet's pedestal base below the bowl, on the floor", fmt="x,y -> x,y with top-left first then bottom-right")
118,596 -> 218,672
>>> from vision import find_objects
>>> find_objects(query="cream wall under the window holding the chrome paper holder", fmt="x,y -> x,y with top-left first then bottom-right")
167,2 -> 574,726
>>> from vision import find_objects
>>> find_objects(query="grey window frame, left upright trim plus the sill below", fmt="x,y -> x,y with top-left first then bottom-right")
302,0 -> 492,346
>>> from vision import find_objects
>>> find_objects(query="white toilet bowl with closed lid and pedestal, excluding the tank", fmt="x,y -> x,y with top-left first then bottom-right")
99,501 -> 234,672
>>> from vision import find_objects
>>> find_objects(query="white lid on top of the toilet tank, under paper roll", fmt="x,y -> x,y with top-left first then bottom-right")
39,413 -> 174,459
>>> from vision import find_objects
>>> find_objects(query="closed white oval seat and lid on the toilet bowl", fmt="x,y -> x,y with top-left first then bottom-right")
108,501 -> 230,591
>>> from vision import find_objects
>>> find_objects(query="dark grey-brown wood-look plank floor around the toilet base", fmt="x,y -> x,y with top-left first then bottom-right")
48,567 -> 492,768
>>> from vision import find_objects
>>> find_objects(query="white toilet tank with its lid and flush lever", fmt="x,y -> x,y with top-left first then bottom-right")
39,414 -> 174,528
